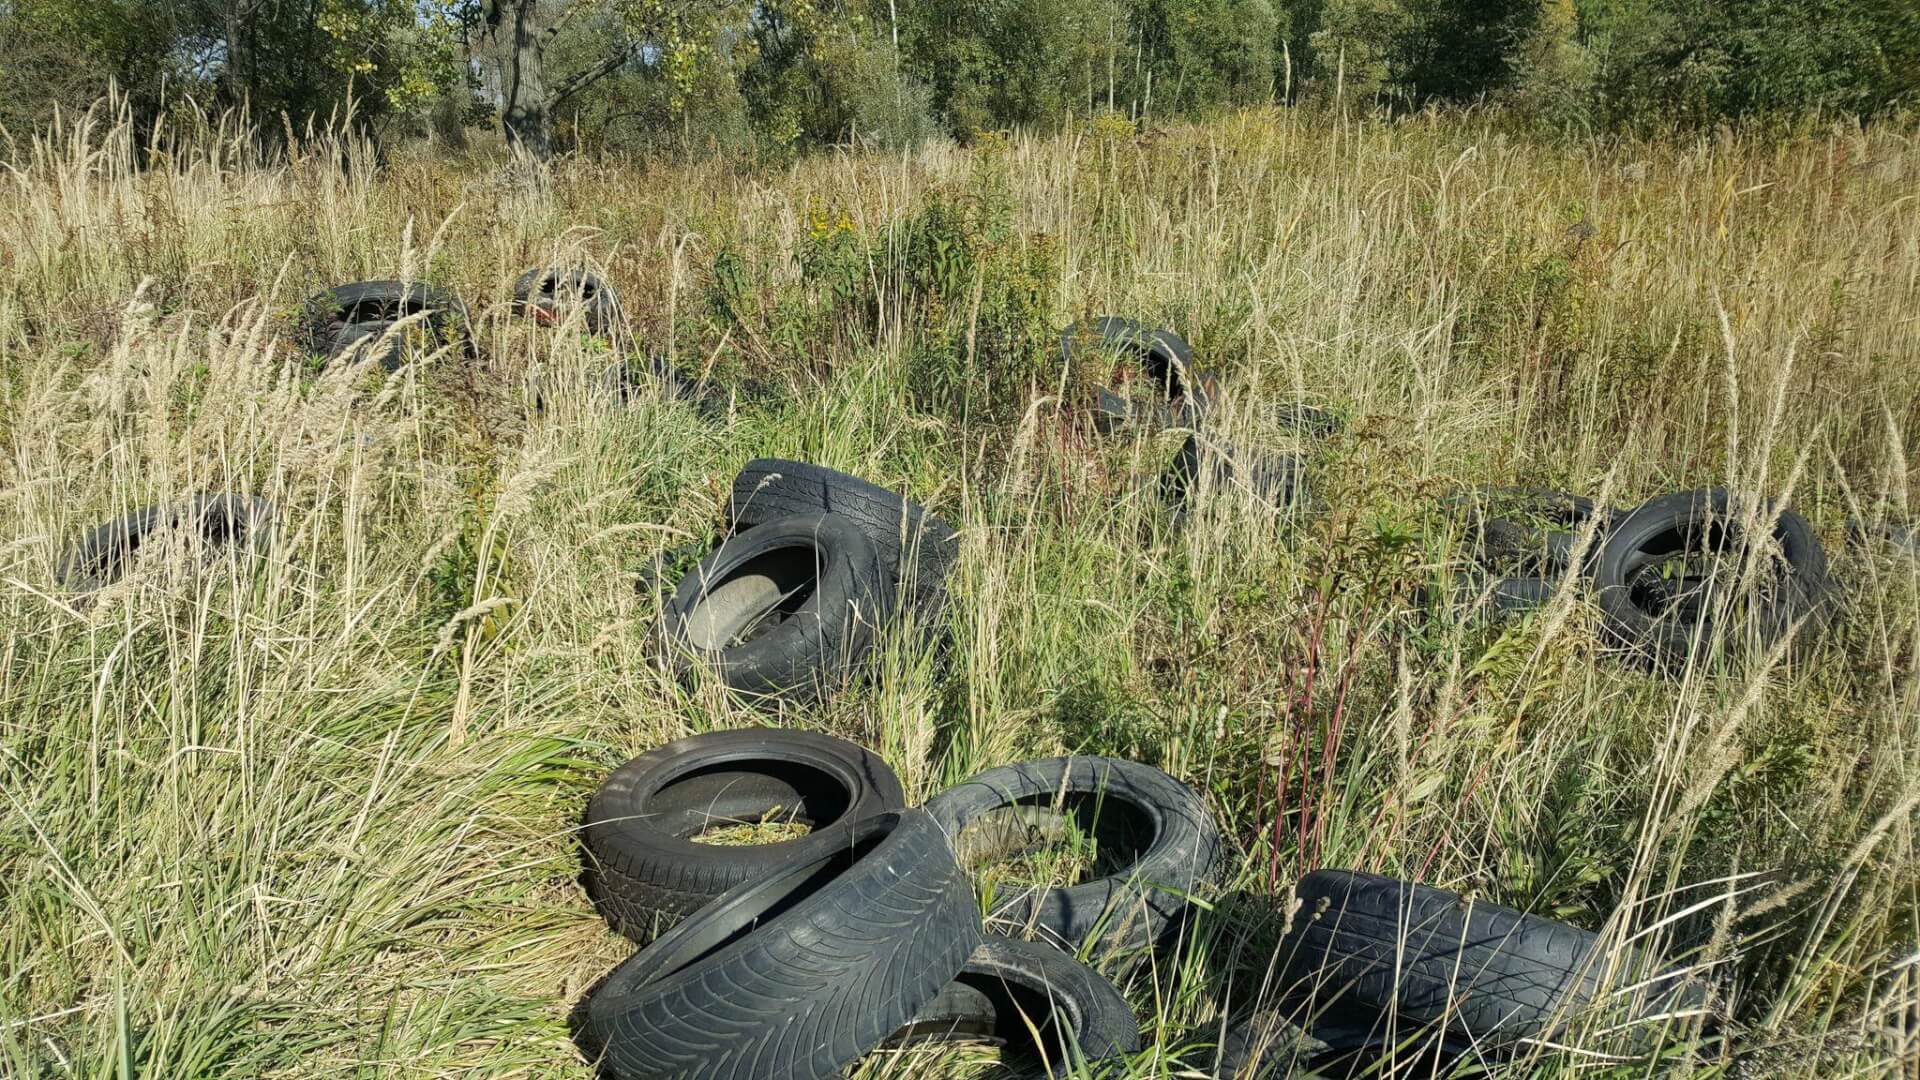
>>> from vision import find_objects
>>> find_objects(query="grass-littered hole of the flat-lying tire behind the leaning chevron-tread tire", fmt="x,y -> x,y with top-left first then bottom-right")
643,759 -> 852,847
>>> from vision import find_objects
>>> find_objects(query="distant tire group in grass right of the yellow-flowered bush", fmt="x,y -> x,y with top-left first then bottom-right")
1060,315 -> 1338,525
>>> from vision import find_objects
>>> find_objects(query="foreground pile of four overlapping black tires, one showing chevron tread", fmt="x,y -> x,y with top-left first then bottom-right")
582,728 -> 1221,1080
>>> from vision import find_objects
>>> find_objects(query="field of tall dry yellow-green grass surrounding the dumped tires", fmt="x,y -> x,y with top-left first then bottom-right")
0,98 -> 1920,1078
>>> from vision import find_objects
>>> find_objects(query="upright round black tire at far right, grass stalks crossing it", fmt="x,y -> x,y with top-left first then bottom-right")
1594,488 -> 1832,665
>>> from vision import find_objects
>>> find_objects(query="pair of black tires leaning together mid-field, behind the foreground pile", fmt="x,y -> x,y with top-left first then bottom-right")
660,457 -> 960,707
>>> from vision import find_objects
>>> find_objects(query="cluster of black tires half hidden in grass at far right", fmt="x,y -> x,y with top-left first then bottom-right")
1453,488 -> 1832,667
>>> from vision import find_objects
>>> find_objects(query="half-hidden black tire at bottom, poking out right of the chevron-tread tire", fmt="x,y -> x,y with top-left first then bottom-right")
887,938 -> 1140,1074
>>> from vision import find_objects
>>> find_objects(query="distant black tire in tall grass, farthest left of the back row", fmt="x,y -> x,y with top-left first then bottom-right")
307,281 -> 474,371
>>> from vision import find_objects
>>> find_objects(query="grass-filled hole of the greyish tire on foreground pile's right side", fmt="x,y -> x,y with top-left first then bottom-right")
954,792 -> 1154,892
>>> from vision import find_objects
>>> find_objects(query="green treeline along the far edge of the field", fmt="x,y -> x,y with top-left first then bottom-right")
0,0 -> 1920,154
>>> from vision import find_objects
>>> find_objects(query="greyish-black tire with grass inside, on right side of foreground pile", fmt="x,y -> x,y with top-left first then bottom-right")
927,757 -> 1221,955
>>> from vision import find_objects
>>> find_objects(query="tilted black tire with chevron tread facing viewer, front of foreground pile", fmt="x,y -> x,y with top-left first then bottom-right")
582,809 -> 981,1080
